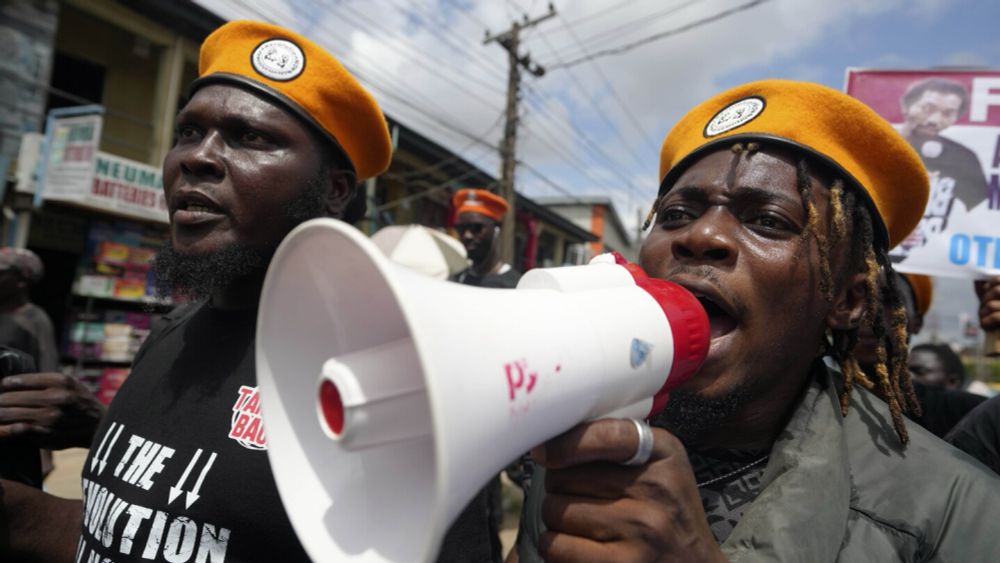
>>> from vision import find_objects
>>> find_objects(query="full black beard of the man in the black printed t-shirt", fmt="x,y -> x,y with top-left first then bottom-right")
153,171 -> 329,299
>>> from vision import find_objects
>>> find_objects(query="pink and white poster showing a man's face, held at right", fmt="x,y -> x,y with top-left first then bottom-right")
846,69 -> 1000,278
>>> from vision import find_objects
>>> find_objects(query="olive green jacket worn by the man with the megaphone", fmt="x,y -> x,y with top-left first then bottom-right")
517,373 -> 1000,563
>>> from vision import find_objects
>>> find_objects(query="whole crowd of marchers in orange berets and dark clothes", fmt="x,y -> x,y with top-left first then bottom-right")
0,17 -> 1000,562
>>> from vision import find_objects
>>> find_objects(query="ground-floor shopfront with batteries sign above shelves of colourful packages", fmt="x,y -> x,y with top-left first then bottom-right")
14,106 -> 172,401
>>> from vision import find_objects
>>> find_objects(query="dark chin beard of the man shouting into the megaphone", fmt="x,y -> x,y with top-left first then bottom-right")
649,385 -> 749,446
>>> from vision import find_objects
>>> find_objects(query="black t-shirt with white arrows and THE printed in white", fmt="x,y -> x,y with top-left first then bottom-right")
77,304 -> 308,563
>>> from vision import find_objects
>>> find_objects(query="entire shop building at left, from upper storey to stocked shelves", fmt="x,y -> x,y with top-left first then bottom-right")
0,0 -> 221,401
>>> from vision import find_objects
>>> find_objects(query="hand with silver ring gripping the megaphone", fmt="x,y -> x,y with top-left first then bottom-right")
515,419 -> 726,563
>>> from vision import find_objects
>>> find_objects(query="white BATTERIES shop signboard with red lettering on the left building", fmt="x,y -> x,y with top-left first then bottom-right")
42,115 -> 168,223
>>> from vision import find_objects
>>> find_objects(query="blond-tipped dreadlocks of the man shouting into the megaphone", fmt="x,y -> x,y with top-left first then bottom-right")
643,142 -> 920,445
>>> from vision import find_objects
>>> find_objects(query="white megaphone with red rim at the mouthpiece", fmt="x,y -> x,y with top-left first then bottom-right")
256,219 -> 709,562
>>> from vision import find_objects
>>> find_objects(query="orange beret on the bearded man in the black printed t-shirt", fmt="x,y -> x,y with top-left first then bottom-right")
191,20 -> 392,179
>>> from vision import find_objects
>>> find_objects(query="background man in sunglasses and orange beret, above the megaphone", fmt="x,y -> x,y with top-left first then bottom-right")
451,188 -> 521,288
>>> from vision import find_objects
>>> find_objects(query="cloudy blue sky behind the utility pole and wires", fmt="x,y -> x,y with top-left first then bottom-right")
198,0 -> 1000,344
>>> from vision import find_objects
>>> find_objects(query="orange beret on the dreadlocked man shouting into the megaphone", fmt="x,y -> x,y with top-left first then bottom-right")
660,80 -> 930,248
